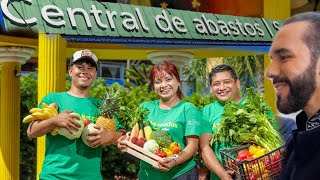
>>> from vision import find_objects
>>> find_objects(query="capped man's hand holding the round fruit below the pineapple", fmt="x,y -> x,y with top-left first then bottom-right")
88,125 -> 114,148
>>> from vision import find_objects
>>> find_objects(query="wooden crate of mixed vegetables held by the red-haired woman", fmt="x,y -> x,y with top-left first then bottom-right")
125,108 -> 181,166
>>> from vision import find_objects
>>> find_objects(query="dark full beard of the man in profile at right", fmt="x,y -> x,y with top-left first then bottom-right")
273,63 -> 316,114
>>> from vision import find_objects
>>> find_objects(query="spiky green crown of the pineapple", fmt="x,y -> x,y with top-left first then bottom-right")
99,88 -> 121,118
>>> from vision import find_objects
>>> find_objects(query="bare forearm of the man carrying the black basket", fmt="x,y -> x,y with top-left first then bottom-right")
201,145 -> 228,179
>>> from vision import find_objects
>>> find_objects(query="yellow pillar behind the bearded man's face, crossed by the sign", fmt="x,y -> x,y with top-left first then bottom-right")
263,0 -> 291,114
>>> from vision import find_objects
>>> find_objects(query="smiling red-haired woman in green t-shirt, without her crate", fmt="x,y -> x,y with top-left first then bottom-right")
119,61 -> 201,180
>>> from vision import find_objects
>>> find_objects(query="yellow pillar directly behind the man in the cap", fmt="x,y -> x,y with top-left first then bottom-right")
37,33 -> 67,179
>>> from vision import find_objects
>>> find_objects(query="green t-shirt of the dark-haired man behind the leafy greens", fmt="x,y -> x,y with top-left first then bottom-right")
201,97 -> 278,180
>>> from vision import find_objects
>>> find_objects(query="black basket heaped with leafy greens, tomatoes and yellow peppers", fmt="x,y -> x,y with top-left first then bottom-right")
212,88 -> 285,179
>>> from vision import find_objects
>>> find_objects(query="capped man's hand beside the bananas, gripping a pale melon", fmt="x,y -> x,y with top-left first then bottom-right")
54,110 -> 81,134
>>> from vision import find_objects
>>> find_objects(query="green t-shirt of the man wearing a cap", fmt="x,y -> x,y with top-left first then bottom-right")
39,92 -> 123,180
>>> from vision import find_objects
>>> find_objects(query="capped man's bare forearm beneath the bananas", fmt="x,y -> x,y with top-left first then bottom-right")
27,117 -> 56,138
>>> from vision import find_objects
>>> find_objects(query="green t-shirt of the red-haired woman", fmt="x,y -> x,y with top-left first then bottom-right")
138,100 -> 201,180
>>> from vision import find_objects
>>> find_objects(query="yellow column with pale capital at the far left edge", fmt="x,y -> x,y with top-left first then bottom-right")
0,46 -> 34,180
